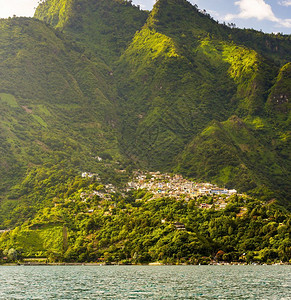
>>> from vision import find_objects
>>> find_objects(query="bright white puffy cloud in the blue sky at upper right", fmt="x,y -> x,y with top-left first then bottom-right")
224,0 -> 291,28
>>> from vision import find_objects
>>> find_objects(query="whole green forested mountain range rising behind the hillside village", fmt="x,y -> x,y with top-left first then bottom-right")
0,0 -> 291,262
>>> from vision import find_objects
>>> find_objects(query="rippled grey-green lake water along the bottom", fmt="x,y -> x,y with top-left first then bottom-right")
0,266 -> 291,300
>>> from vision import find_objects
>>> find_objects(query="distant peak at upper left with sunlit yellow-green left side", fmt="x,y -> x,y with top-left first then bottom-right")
35,0 -> 148,64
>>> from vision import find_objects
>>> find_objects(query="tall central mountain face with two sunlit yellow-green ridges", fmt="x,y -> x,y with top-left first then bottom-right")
113,1 -> 286,202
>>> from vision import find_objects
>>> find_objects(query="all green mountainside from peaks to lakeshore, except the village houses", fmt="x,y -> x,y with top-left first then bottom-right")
0,0 -> 291,263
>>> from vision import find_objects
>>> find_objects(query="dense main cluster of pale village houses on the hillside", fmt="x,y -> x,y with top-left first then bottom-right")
127,172 -> 237,199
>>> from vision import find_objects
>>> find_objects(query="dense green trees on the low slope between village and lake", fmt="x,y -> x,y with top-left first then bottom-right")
0,176 -> 291,264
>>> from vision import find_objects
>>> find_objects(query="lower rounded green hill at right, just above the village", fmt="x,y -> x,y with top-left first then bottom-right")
178,116 -> 290,198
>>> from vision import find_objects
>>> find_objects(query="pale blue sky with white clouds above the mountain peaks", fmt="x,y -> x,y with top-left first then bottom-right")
0,0 -> 291,34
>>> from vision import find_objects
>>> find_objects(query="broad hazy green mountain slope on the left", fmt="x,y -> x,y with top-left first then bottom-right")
0,18 -> 119,225
